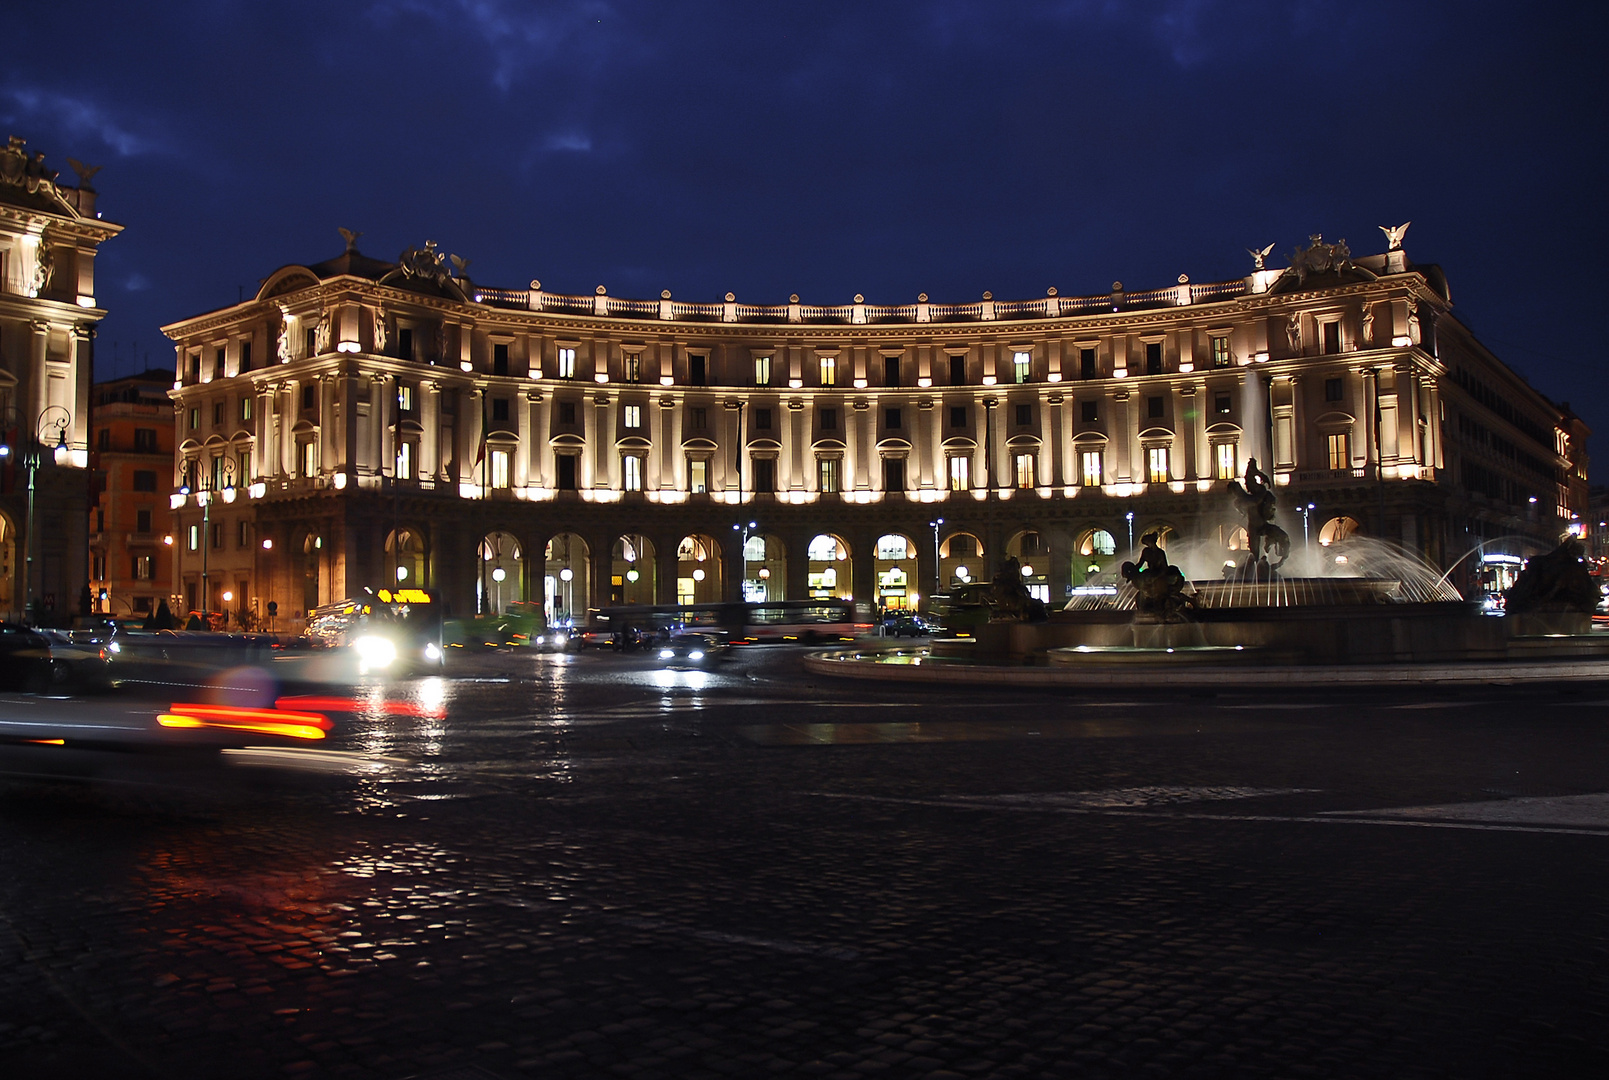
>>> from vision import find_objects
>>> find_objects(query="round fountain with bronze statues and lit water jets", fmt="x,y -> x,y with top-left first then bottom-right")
809,459 -> 1609,684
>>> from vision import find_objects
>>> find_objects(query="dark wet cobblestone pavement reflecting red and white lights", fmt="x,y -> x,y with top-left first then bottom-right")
0,650 -> 1609,1080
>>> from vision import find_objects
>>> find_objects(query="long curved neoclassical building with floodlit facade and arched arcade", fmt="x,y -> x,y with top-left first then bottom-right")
164,230 -> 1586,628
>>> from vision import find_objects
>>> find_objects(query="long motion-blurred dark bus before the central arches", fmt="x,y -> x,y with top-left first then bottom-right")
581,600 -> 877,649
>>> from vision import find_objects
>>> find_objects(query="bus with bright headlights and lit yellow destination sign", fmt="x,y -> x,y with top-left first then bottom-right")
307,589 -> 442,673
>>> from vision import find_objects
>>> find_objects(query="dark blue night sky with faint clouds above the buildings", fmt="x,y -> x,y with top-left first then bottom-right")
0,0 -> 1609,444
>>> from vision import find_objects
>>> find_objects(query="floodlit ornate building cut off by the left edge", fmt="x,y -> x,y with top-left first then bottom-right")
0,135 -> 122,621
